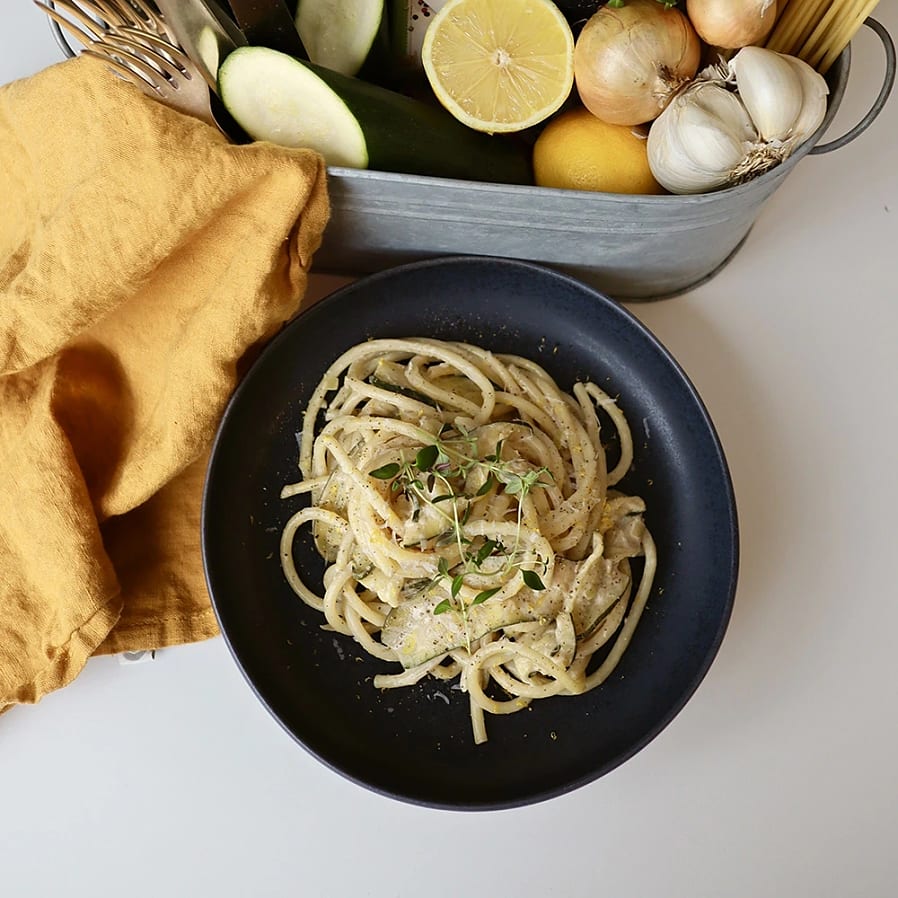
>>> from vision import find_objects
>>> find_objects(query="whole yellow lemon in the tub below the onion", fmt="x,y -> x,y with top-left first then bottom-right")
533,109 -> 664,194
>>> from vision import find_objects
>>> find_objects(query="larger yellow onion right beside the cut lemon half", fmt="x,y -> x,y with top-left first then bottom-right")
574,0 -> 701,125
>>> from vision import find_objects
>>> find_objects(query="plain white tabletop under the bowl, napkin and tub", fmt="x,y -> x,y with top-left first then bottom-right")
0,7 -> 898,898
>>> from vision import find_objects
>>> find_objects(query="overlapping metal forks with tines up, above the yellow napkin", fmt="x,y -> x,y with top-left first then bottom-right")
33,0 -> 221,130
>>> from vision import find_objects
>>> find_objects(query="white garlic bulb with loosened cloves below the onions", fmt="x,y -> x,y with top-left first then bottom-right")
647,47 -> 828,194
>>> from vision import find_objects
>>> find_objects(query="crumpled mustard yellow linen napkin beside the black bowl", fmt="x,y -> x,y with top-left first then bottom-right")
0,58 -> 329,710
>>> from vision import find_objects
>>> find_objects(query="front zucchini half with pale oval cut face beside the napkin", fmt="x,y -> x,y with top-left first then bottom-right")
218,47 -> 532,184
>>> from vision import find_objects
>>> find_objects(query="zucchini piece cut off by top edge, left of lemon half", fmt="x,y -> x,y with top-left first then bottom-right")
296,0 -> 388,75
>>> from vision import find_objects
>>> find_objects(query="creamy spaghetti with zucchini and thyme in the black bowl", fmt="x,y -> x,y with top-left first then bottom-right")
281,339 -> 656,743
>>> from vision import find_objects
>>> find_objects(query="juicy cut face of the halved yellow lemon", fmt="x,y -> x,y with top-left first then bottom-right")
421,0 -> 574,133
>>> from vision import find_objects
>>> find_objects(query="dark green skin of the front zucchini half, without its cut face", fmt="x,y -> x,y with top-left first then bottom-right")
299,60 -> 533,184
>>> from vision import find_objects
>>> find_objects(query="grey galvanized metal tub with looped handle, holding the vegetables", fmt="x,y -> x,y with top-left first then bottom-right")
314,19 -> 895,300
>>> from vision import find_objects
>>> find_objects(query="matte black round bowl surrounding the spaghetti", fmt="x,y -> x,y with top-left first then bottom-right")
202,257 -> 738,810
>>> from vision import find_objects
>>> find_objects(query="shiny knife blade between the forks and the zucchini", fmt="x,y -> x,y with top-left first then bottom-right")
156,0 -> 246,91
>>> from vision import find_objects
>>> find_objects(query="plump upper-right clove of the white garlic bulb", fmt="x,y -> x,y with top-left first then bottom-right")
729,47 -> 804,141
